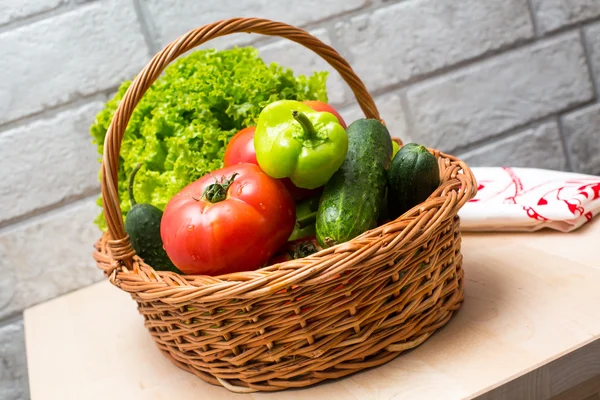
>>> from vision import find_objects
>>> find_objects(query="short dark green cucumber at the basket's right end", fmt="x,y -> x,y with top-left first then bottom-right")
388,143 -> 440,219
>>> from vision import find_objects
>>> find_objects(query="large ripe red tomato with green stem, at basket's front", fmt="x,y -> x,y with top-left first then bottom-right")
160,163 -> 296,275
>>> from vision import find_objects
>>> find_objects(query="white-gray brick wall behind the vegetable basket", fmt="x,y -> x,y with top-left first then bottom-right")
0,0 -> 600,400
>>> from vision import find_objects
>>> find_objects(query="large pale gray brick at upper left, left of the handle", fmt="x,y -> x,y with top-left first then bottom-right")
0,0 -> 149,123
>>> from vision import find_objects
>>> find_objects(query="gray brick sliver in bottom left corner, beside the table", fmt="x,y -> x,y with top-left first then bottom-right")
0,318 -> 29,400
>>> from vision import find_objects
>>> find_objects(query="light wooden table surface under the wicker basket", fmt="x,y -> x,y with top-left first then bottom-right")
25,218 -> 600,400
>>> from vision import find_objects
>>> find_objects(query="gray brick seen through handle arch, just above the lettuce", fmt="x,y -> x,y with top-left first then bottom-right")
260,29 -> 349,105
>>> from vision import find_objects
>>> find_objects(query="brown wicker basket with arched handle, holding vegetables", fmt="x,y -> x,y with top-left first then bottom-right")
94,18 -> 477,392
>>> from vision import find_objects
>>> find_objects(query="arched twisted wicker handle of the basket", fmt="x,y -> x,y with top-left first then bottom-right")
101,18 -> 380,268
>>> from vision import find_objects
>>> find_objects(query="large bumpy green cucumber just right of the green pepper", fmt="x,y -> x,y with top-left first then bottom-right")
316,119 -> 392,247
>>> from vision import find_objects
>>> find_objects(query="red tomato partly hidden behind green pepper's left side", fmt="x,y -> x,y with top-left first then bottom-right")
223,126 -> 321,200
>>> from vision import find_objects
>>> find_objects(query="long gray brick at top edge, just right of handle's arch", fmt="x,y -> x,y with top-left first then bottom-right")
336,0 -> 533,90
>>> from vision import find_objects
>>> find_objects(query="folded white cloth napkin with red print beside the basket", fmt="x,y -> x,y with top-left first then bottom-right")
459,167 -> 600,232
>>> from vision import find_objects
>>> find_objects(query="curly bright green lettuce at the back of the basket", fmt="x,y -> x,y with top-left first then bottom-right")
91,47 -> 327,229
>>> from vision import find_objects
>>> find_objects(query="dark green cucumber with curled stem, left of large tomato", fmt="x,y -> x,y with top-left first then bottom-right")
125,164 -> 181,273
